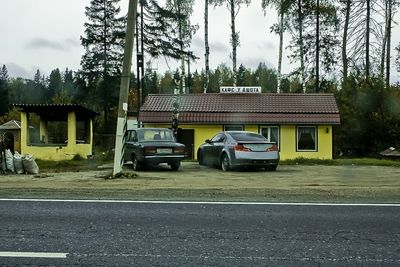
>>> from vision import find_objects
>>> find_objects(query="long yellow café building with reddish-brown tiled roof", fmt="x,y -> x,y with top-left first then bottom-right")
138,91 -> 340,160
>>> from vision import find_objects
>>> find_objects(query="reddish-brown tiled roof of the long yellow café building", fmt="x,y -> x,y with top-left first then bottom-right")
139,93 -> 340,124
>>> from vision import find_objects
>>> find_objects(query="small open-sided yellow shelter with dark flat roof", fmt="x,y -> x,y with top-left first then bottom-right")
14,104 -> 98,161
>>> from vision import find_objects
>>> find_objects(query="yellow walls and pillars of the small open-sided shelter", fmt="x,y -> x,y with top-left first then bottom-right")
21,112 -> 93,161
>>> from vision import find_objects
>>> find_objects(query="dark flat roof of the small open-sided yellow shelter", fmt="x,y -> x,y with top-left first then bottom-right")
13,104 -> 99,121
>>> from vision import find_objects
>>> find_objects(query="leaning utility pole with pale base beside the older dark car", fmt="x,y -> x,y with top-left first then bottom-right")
113,0 -> 138,175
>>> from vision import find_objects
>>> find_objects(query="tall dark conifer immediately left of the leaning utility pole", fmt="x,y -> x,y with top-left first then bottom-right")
80,0 -> 126,131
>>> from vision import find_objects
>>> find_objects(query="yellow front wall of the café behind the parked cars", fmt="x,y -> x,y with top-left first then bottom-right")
145,124 -> 333,160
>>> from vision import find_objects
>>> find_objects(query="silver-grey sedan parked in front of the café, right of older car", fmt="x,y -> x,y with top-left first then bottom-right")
197,131 -> 279,171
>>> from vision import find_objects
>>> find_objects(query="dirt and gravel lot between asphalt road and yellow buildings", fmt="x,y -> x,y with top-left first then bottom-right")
0,162 -> 400,203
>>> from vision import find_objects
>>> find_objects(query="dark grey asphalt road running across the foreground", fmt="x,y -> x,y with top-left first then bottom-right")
0,200 -> 400,266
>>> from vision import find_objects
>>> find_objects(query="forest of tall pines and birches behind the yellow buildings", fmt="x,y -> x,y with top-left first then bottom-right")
0,0 -> 400,156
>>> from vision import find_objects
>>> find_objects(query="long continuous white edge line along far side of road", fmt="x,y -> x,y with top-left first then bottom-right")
0,198 -> 400,207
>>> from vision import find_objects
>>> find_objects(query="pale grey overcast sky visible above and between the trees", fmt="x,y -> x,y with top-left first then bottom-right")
0,0 -> 400,80
